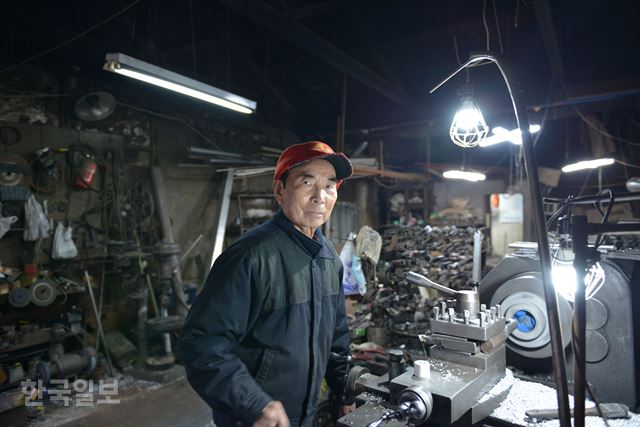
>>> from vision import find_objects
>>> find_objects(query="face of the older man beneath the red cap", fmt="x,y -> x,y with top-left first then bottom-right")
273,159 -> 338,237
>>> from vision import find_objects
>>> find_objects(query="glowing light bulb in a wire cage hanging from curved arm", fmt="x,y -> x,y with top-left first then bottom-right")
449,84 -> 489,148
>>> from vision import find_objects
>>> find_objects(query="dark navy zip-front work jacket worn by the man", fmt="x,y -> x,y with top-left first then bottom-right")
180,211 -> 349,426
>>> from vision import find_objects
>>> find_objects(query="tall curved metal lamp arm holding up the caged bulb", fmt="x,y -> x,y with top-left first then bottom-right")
429,53 -> 571,427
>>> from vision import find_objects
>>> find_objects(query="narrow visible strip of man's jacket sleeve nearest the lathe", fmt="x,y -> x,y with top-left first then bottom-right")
325,269 -> 354,404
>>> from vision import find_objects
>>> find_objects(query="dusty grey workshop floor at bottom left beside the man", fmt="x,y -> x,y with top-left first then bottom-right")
0,378 -> 212,427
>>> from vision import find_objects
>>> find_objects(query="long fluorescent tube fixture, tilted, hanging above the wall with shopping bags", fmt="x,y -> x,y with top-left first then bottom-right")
103,53 -> 256,114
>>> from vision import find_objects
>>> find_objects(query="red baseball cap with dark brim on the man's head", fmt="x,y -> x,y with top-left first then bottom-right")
273,141 -> 353,186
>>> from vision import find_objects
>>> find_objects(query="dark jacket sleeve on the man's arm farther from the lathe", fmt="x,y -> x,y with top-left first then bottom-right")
180,250 -> 273,425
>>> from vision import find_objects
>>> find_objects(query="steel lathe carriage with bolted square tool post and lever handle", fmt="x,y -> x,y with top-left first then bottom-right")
338,272 -> 516,427
